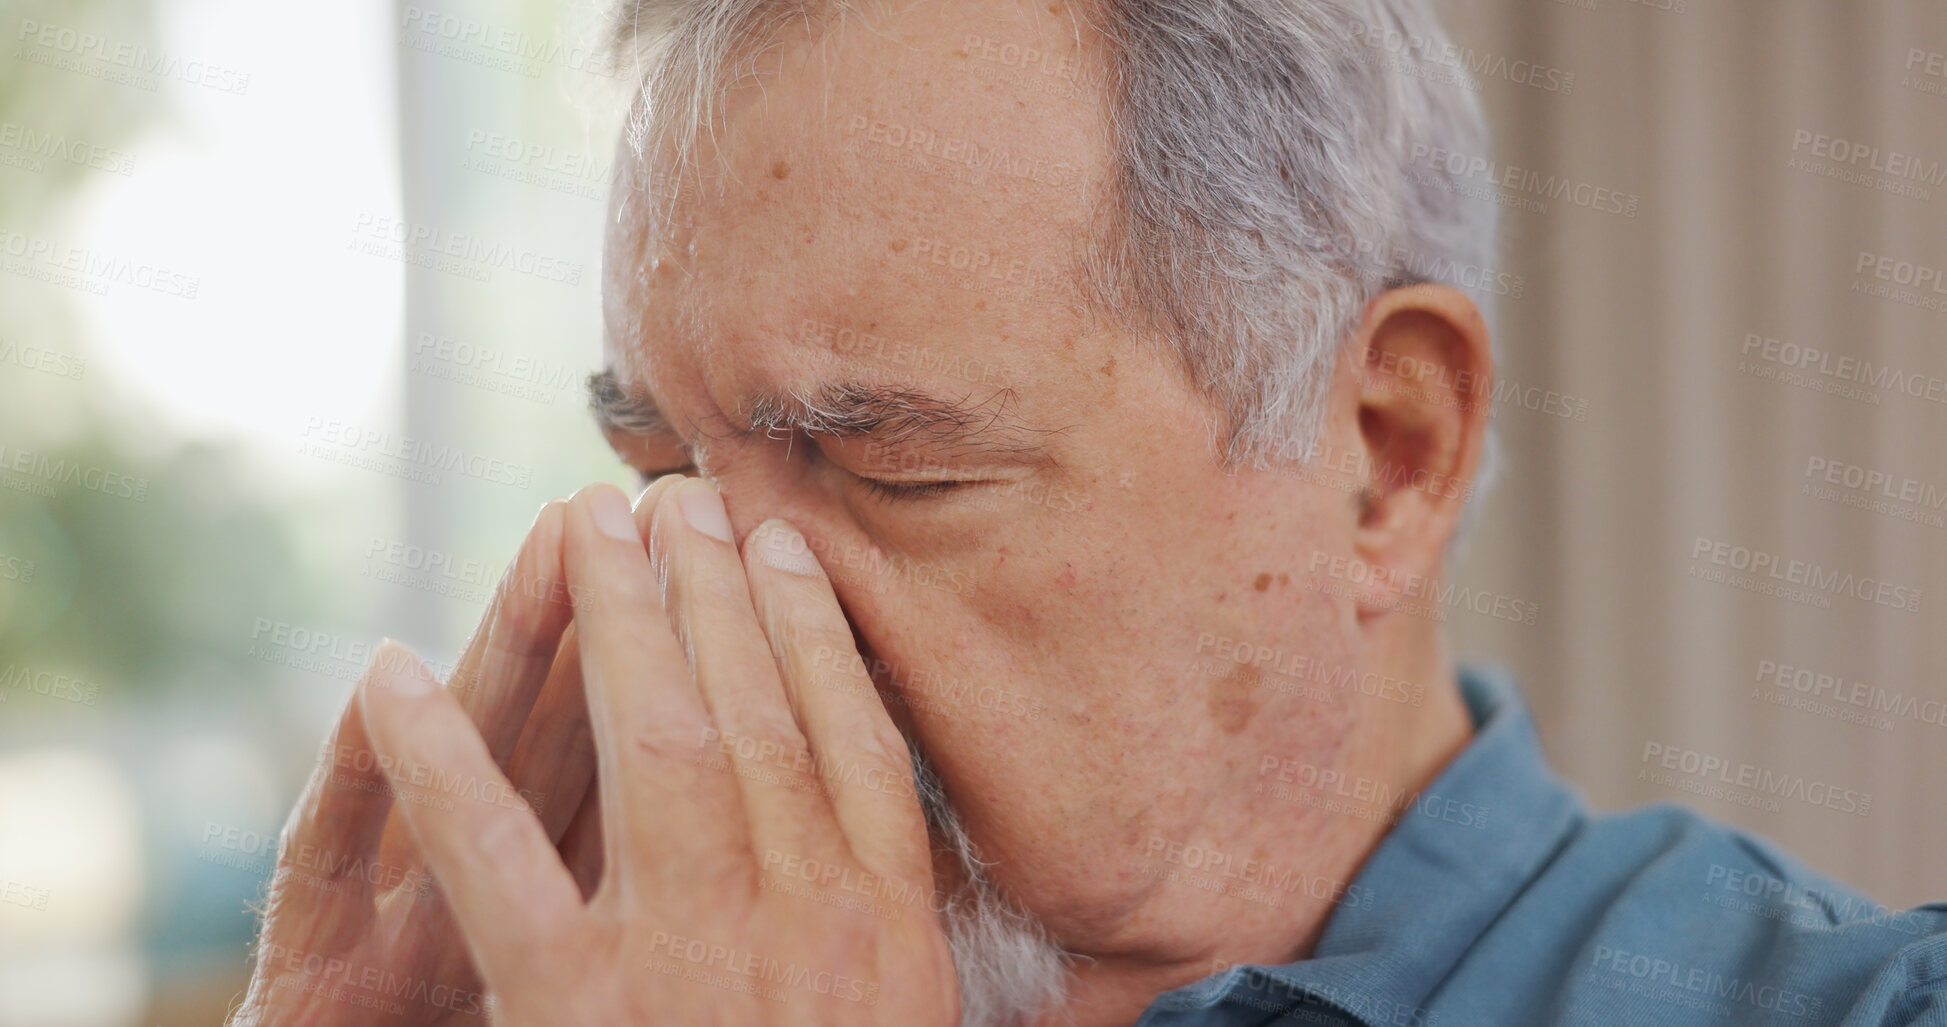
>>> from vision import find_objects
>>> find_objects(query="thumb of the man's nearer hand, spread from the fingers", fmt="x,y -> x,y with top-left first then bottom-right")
356,641 -> 582,994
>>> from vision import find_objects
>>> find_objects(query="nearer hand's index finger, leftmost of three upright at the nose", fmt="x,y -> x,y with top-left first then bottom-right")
565,483 -> 750,896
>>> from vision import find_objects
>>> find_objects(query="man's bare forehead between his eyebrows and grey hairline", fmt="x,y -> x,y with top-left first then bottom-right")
609,0 -> 1108,422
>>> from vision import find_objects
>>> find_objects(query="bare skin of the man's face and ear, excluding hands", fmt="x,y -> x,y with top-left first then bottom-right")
607,4 -> 1489,1023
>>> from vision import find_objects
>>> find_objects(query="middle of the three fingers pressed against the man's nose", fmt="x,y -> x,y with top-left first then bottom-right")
648,479 -> 843,859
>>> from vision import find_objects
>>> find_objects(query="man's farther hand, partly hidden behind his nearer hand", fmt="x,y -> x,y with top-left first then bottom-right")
230,501 -> 619,1027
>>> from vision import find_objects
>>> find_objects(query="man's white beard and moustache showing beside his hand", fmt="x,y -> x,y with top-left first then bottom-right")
911,744 -> 1071,1027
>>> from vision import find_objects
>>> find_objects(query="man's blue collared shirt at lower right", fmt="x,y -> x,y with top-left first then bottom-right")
1137,666 -> 1947,1027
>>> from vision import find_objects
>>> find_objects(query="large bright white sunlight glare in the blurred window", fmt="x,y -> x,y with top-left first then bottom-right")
70,0 -> 403,474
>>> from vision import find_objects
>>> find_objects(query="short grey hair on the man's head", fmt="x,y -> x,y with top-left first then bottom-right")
609,0 -> 1497,534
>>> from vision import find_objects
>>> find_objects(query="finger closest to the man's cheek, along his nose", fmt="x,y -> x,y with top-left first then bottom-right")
744,518 -> 933,887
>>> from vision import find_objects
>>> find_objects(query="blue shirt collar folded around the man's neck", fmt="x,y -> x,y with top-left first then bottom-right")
1172,666 -> 1585,1023
